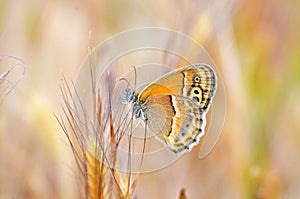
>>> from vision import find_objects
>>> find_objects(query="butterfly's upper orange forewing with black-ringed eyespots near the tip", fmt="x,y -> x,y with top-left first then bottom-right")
139,64 -> 216,110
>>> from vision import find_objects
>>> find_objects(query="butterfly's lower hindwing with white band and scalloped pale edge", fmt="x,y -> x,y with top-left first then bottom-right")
147,95 -> 205,153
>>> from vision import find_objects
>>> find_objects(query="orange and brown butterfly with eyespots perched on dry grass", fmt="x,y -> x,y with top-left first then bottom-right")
124,64 -> 217,153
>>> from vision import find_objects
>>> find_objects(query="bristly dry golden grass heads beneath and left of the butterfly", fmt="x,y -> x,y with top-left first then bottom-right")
57,65 -> 136,199
